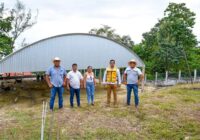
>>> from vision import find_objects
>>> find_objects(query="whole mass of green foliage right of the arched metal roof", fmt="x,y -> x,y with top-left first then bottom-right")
133,3 -> 200,73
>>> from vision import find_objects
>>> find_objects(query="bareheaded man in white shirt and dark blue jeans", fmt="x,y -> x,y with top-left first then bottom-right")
67,64 -> 83,107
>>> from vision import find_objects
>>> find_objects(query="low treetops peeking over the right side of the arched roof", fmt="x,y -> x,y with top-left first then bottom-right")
89,25 -> 134,47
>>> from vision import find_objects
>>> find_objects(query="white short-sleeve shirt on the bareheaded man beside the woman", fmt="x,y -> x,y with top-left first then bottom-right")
67,71 -> 83,89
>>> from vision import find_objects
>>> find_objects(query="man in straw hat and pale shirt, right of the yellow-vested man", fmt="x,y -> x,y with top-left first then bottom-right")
123,59 -> 143,110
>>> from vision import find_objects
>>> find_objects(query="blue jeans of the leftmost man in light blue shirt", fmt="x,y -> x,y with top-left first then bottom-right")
50,86 -> 64,109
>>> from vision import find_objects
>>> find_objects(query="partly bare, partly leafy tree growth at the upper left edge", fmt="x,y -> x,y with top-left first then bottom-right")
0,0 -> 38,59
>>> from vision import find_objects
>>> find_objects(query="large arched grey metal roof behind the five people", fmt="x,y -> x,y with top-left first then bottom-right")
0,33 -> 145,73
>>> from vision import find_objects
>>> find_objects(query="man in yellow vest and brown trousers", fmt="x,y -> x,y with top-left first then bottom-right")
103,59 -> 121,106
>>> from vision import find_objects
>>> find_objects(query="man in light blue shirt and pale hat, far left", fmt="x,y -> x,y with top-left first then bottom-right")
46,57 -> 67,111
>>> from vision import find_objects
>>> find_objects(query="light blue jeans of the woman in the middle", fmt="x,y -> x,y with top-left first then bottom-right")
86,82 -> 95,104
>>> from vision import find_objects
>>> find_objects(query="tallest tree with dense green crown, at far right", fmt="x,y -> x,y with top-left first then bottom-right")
158,3 -> 197,70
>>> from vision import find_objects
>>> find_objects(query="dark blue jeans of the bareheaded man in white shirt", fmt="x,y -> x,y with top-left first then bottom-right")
70,87 -> 80,107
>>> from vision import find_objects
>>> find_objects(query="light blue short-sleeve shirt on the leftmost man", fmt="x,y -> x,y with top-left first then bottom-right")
46,66 -> 67,87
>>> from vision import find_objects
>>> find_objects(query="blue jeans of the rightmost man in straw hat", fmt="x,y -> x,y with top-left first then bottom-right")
127,84 -> 139,106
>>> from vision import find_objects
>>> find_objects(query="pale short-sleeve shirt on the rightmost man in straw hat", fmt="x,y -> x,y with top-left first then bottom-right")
124,67 -> 142,84
